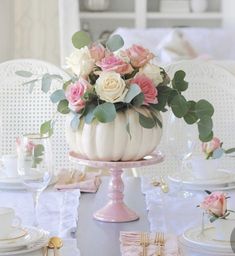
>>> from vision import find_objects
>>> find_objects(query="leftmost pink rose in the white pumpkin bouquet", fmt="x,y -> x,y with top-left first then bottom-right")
65,78 -> 91,112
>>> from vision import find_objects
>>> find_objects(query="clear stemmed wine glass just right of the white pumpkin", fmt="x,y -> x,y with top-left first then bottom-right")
166,112 -> 197,198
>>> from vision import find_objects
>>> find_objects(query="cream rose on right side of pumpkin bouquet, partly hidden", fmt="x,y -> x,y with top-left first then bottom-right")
139,63 -> 163,86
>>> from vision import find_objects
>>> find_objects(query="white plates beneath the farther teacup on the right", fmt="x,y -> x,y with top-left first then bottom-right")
168,169 -> 235,190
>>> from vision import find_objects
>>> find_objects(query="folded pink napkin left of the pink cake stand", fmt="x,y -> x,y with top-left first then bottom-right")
55,169 -> 101,193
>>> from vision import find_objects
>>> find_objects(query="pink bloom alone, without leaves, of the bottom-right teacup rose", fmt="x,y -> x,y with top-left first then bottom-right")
200,192 -> 227,217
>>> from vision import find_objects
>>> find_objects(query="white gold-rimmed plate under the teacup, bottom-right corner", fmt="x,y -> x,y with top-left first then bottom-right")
182,226 -> 232,253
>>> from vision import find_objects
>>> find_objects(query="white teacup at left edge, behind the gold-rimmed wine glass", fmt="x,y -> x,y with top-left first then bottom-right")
1,154 -> 18,177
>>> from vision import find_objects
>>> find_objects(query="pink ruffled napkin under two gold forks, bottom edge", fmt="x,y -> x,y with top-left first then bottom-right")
120,231 -> 180,256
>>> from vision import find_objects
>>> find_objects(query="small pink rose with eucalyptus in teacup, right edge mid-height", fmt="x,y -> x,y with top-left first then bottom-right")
202,137 -> 235,159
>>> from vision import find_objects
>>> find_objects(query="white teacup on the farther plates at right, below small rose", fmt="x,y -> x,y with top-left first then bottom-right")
186,156 -> 220,179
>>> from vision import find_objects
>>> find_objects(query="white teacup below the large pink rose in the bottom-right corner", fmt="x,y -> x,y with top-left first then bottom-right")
212,213 -> 235,242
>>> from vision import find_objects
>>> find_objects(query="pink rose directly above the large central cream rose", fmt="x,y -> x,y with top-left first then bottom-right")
96,55 -> 133,75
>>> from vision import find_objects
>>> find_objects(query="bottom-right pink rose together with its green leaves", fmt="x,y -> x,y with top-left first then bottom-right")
198,190 -> 233,222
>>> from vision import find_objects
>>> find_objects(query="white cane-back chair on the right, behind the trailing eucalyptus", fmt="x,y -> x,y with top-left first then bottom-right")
136,60 -> 235,176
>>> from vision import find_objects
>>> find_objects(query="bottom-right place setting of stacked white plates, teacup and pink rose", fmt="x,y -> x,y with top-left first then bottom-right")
179,191 -> 235,255
